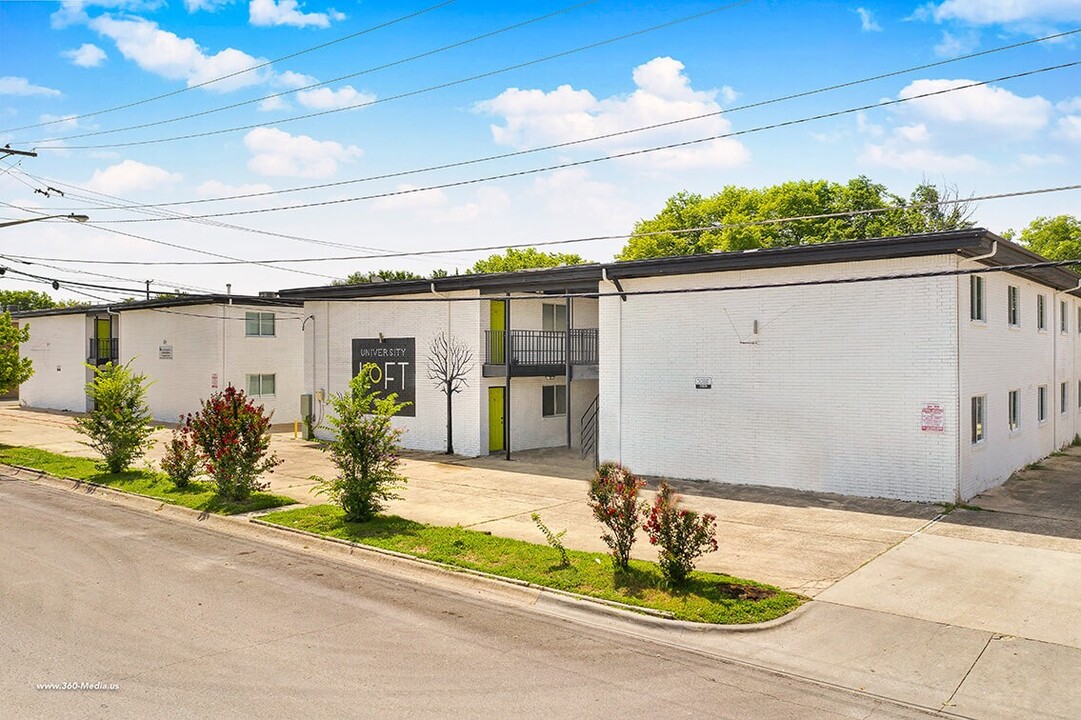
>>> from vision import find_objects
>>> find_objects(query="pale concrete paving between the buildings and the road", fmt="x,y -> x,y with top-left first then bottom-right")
0,399 -> 1081,719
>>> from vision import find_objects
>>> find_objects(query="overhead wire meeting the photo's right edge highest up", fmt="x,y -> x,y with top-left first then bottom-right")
39,28 -> 1081,210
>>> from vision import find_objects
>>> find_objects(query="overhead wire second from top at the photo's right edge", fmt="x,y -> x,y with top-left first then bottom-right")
90,61 -> 1081,226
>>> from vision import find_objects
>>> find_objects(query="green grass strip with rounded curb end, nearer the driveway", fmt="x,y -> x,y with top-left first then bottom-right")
262,505 -> 804,624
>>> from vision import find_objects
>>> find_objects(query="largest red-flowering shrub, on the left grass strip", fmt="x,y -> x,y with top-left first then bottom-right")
191,385 -> 282,501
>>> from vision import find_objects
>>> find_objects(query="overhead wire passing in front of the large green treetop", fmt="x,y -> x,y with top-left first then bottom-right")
5,184 -> 1081,265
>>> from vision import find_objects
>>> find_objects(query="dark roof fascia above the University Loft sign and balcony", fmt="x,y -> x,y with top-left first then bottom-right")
278,263 -> 602,301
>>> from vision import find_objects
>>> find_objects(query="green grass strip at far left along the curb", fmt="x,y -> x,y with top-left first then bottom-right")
0,445 -> 296,515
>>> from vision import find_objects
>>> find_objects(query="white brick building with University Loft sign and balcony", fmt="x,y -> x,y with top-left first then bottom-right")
281,229 -> 1081,501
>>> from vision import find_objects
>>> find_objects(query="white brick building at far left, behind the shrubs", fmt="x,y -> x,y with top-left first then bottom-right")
16,295 -> 304,425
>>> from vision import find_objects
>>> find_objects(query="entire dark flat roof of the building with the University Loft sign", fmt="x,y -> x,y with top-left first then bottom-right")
279,228 -> 1081,301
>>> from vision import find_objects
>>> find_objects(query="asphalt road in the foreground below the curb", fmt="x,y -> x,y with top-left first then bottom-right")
0,479 -> 929,719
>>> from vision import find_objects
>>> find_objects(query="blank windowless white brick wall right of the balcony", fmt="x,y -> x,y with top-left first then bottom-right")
600,256 -> 958,501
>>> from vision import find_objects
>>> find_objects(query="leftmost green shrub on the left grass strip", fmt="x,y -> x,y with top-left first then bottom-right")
75,362 -> 154,472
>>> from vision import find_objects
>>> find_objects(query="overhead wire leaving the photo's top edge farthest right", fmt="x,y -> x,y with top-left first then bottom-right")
25,0 -> 751,150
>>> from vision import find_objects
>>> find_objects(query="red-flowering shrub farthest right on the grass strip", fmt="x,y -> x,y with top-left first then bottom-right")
643,482 -> 717,587
